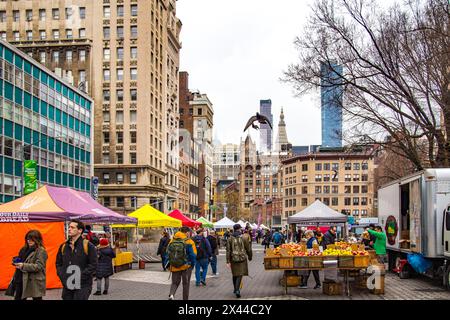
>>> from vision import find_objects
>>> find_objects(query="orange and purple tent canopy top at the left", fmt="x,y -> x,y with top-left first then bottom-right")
0,186 -> 137,223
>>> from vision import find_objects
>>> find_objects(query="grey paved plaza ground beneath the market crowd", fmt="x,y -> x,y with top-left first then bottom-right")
0,244 -> 450,300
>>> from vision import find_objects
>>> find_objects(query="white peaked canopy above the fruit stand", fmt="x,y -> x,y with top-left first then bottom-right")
288,200 -> 347,224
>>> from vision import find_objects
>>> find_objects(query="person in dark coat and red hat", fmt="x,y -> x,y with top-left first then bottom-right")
94,238 -> 116,296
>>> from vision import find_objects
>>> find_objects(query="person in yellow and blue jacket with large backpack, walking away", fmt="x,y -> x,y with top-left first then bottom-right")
167,227 -> 197,300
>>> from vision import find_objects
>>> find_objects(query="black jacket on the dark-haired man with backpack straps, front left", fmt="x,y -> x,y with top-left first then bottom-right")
56,237 -> 98,288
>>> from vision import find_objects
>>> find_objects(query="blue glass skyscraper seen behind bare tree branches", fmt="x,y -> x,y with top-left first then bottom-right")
320,62 -> 343,148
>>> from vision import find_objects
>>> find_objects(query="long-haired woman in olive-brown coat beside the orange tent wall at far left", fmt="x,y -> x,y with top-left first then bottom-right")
5,230 -> 48,300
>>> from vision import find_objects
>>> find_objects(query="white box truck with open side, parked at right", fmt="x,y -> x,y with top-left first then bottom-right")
378,168 -> 450,290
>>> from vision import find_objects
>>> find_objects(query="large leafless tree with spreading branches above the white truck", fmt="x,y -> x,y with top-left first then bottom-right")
282,0 -> 450,170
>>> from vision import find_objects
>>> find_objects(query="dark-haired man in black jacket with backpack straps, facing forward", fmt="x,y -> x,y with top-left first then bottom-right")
56,220 -> 98,300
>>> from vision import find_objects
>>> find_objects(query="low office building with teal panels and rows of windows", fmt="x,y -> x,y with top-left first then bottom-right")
0,41 -> 93,203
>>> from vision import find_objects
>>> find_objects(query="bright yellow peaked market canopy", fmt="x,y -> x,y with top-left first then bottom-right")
112,204 -> 181,228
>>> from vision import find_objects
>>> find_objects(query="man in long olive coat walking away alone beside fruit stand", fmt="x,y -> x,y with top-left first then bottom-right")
226,224 -> 253,298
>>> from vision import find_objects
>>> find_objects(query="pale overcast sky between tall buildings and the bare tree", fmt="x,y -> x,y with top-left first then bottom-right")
177,0 -> 321,145
